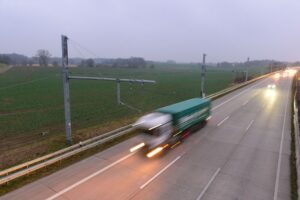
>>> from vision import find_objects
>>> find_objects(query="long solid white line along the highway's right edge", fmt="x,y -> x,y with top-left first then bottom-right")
273,80 -> 290,200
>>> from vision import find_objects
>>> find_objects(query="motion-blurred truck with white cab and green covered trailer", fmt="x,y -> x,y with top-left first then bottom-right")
130,98 -> 211,158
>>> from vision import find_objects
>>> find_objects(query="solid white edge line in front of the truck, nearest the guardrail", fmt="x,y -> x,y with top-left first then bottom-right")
46,152 -> 136,200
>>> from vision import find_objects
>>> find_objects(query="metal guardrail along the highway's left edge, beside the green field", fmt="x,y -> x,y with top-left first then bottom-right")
0,72 -> 275,185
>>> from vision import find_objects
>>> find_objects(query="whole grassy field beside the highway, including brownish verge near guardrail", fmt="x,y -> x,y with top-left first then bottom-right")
0,65 -> 268,168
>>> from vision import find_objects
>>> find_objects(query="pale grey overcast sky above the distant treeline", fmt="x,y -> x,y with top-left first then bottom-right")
0,0 -> 300,62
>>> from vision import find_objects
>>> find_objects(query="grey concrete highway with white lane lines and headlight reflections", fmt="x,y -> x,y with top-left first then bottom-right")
0,72 -> 292,200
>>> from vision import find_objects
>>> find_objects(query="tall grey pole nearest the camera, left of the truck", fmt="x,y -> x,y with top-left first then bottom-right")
61,35 -> 72,145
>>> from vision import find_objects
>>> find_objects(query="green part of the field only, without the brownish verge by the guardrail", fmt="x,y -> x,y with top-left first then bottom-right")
0,68 -> 232,137
